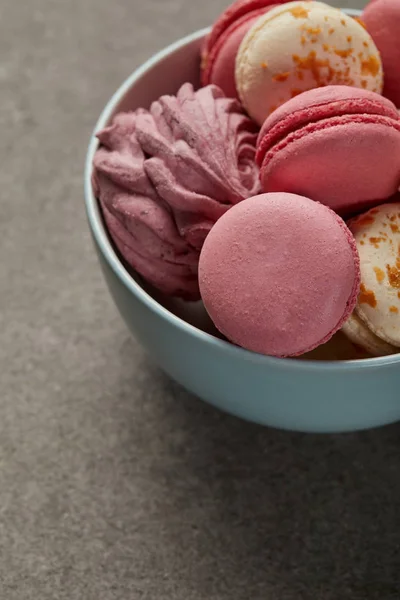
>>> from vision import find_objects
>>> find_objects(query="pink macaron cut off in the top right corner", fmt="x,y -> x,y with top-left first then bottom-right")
362,0 -> 400,107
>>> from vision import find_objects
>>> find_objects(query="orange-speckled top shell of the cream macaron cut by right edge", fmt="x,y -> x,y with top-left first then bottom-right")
349,202 -> 400,347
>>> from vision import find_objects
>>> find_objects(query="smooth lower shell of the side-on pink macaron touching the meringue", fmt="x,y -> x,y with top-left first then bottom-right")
261,114 -> 400,214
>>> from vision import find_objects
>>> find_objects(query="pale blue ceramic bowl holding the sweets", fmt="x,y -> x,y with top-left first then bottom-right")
85,11 -> 400,432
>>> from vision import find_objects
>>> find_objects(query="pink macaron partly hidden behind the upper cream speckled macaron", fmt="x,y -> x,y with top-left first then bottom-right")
201,0 -> 287,98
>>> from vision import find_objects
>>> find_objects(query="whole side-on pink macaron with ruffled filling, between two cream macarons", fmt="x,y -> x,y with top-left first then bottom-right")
257,86 -> 400,214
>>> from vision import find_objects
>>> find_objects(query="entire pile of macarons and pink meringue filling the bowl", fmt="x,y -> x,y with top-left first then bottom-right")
93,0 -> 400,357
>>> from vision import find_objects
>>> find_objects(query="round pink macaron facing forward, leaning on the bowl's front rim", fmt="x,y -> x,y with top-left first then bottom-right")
199,193 -> 360,357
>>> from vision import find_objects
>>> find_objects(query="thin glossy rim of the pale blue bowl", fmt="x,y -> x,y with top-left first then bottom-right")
84,16 -> 400,373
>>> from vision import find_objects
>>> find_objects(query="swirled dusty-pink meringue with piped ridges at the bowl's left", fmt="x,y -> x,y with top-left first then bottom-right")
93,84 -> 260,300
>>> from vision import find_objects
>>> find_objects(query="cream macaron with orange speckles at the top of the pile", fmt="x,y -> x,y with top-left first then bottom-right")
235,1 -> 383,125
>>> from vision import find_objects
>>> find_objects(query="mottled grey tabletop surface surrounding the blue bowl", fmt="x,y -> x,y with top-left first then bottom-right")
0,0 -> 400,600
